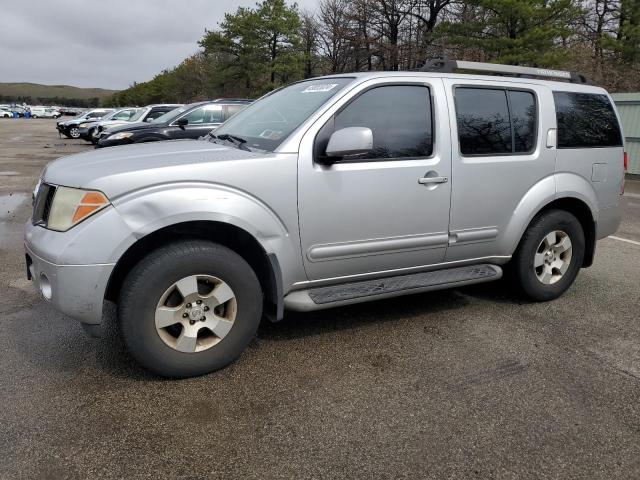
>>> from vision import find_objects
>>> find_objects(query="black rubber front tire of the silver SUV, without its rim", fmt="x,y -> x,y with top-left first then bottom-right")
118,240 -> 262,378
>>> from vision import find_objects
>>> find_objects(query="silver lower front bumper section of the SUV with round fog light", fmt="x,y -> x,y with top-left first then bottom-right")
25,244 -> 115,324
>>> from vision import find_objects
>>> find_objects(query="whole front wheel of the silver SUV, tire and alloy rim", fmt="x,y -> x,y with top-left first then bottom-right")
119,240 -> 262,377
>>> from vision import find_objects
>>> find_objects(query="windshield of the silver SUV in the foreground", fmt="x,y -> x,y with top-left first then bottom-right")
212,78 -> 353,152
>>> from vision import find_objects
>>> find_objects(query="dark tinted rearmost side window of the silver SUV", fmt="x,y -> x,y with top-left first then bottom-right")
553,92 -> 622,148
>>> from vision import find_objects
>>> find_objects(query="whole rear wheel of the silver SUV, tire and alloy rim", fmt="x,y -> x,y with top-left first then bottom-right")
513,210 -> 585,301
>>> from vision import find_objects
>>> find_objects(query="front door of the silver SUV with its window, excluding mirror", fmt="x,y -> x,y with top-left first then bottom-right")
298,77 -> 451,280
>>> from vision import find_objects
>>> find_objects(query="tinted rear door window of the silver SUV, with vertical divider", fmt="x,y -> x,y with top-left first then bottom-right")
455,87 -> 538,156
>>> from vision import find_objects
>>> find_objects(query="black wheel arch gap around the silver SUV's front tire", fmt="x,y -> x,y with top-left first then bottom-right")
105,220 -> 284,321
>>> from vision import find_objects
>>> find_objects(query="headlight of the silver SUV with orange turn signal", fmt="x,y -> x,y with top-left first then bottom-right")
47,187 -> 109,232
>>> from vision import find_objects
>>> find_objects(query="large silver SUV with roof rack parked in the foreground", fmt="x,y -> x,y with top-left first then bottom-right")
25,62 -> 624,377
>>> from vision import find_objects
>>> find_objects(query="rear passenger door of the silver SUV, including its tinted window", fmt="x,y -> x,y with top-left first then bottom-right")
445,79 -> 556,261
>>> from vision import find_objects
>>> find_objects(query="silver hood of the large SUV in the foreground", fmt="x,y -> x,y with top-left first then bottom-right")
43,140 -> 268,200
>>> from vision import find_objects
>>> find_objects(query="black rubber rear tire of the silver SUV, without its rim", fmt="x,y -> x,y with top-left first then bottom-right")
511,210 -> 585,302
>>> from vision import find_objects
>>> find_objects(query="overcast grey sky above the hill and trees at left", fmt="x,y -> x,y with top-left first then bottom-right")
0,0 -> 317,89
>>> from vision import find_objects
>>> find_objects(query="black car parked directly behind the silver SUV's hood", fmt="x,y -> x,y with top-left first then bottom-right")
97,98 -> 251,148
